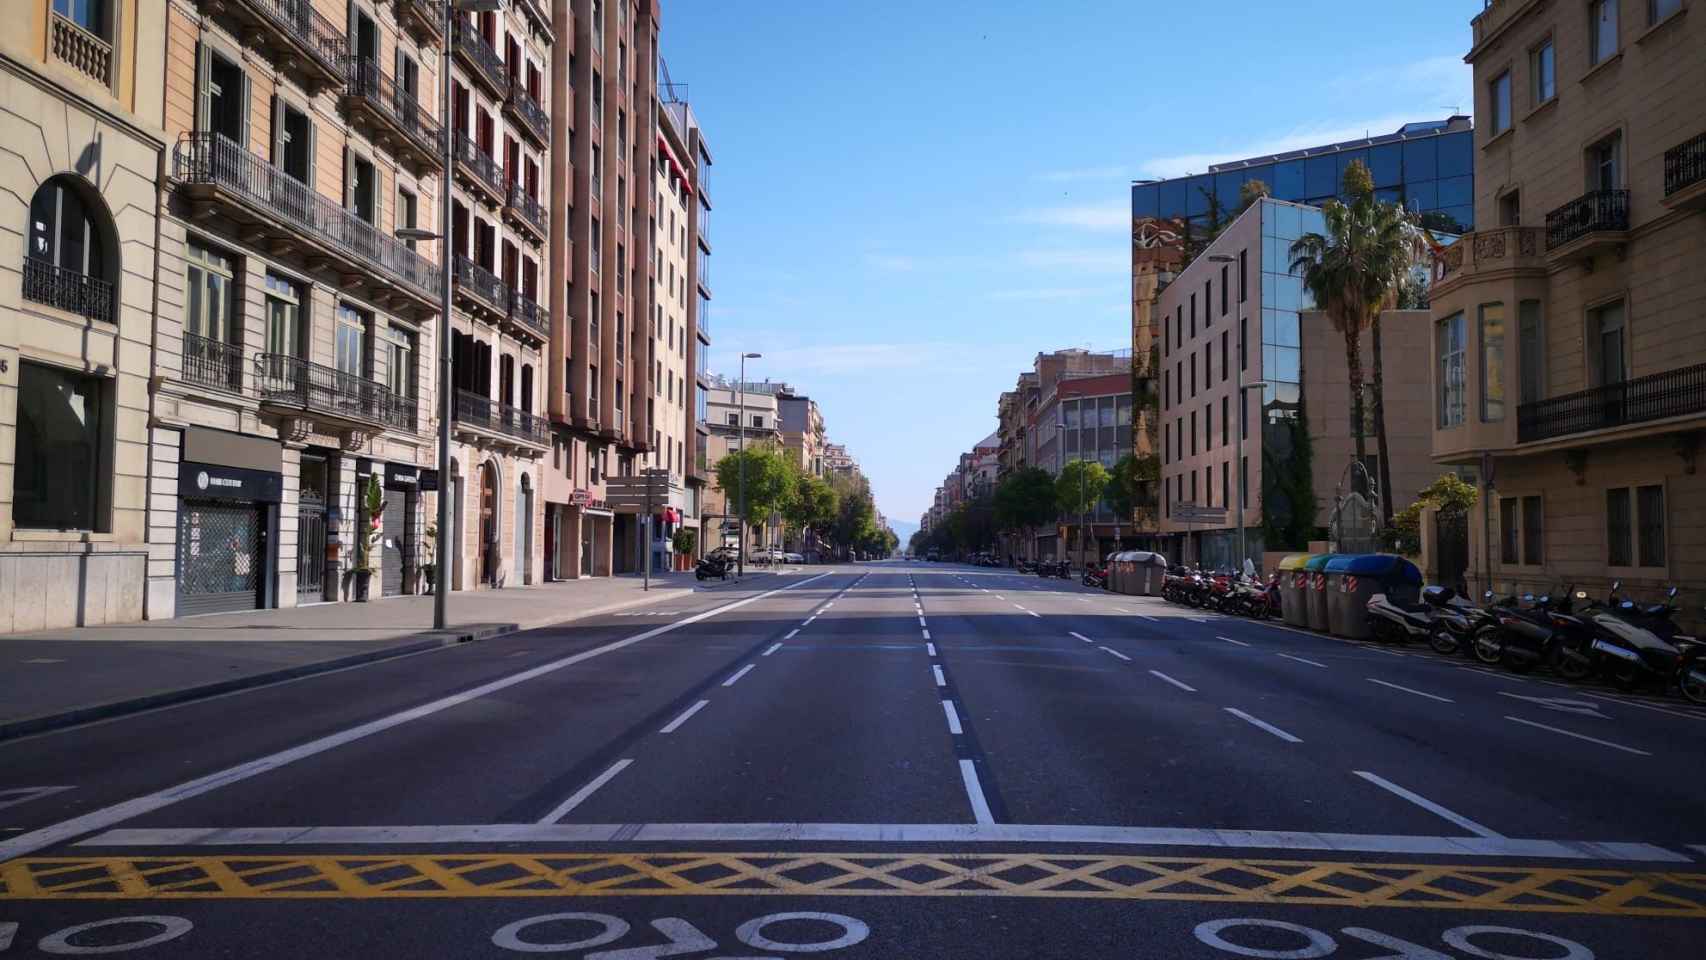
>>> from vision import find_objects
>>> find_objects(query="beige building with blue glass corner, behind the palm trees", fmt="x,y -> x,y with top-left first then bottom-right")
1155,200 -> 1438,566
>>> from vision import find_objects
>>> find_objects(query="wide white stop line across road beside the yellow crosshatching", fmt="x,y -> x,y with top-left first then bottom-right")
89,825 -> 1678,863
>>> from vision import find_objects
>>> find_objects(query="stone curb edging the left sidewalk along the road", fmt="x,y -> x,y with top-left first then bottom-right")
0,578 -> 699,742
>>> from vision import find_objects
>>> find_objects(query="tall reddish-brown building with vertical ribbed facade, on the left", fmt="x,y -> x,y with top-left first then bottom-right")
544,0 -> 662,580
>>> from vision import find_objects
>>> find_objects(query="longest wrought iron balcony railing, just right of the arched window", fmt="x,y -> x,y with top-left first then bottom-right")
172,133 -> 442,300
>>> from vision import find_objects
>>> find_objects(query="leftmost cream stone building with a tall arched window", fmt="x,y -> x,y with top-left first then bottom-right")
0,0 -> 165,633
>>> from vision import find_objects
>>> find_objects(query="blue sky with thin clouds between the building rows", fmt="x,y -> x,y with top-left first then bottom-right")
662,0 -> 1483,520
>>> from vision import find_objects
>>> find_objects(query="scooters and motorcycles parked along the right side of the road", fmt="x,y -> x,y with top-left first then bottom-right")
1162,568 -> 1706,704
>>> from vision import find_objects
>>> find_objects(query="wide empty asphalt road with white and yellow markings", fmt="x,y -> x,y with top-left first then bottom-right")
0,563 -> 1706,960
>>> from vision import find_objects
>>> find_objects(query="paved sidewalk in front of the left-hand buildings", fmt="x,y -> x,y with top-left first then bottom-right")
0,573 -> 774,740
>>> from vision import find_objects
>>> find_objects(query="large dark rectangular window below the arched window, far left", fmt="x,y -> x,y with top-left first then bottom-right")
12,361 -> 111,532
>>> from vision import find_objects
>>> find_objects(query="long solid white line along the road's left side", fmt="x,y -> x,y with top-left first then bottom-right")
0,573 -> 829,863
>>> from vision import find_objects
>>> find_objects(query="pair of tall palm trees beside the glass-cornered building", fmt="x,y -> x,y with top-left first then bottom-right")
1290,160 -> 1418,520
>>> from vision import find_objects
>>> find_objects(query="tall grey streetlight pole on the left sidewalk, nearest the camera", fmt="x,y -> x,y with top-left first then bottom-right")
396,0 -> 503,629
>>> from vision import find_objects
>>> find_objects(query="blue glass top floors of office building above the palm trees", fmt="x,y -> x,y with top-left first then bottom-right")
1131,116 -> 1476,234
